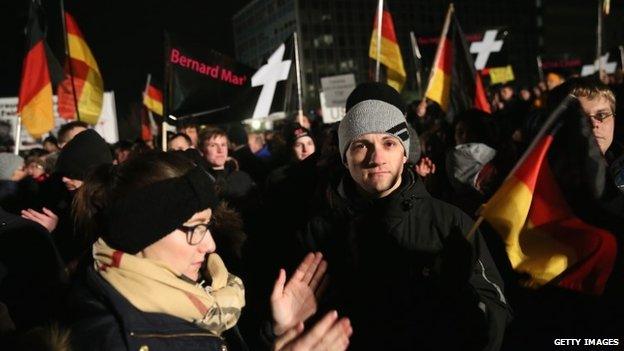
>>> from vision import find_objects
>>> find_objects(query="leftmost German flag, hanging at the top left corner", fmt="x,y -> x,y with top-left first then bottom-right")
17,1 -> 56,138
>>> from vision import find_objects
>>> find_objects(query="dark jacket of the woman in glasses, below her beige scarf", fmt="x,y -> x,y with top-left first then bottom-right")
68,267 -> 227,351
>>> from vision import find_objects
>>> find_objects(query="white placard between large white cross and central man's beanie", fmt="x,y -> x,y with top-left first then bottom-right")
319,74 -> 355,123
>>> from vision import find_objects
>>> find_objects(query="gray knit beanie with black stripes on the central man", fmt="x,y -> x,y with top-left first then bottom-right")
338,100 -> 410,161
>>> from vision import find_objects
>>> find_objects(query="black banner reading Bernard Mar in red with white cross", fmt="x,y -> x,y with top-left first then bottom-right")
165,34 -> 296,124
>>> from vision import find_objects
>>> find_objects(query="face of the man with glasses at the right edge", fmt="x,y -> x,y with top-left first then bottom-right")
579,96 -> 615,155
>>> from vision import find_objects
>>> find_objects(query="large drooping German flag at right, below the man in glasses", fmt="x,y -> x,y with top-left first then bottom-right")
481,125 -> 617,294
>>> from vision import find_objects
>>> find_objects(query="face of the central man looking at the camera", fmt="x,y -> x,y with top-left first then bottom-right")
346,133 -> 407,198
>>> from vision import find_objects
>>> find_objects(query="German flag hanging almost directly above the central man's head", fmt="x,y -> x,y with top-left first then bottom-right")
368,1 -> 407,92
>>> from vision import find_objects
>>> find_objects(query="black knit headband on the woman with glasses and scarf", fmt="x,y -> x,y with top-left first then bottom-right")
103,167 -> 219,254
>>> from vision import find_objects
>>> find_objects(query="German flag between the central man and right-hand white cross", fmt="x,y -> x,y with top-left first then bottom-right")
425,4 -> 491,118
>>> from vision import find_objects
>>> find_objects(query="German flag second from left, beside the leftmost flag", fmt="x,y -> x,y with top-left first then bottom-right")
57,12 -> 104,125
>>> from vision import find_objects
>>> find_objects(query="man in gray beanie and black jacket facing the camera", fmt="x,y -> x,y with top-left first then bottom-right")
297,83 -> 510,350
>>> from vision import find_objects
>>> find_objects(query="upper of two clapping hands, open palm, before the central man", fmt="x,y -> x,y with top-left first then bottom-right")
271,252 -> 327,335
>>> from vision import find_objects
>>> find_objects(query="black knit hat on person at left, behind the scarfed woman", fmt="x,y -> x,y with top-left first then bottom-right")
55,129 -> 113,180
